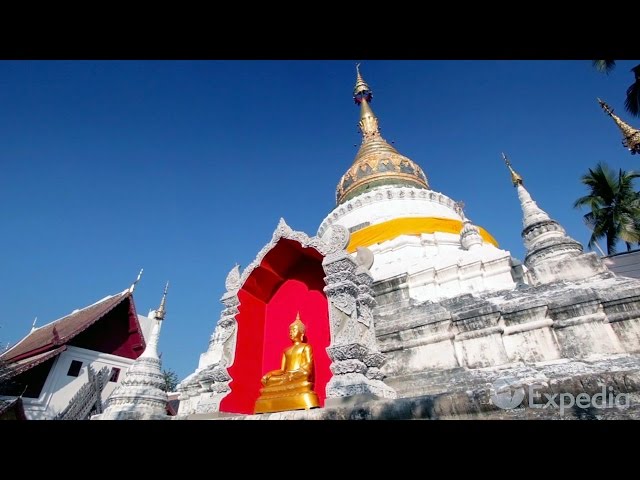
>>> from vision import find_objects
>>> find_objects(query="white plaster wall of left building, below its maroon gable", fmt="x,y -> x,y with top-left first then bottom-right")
23,347 -> 134,420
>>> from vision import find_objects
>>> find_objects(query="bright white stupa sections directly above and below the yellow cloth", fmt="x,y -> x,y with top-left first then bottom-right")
318,186 -> 515,301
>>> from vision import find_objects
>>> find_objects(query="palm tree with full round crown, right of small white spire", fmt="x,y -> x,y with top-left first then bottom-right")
573,162 -> 640,255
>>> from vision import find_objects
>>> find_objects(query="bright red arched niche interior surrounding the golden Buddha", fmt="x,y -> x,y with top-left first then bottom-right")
220,239 -> 331,414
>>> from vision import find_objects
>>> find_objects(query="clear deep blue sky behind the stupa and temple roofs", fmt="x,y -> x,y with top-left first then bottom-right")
0,59 -> 640,379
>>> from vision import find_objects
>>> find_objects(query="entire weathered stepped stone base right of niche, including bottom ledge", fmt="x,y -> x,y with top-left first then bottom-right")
176,277 -> 640,420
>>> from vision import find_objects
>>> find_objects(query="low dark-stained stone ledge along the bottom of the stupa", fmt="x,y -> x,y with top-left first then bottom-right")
176,357 -> 640,420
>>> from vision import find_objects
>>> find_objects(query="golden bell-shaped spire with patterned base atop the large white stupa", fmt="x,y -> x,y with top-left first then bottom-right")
336,64 -> 429,205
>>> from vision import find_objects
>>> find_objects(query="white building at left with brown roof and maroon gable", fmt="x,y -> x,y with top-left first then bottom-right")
0,272 -> 172,420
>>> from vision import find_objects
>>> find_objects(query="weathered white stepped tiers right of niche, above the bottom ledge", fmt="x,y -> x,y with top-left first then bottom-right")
373,270 -> 640,404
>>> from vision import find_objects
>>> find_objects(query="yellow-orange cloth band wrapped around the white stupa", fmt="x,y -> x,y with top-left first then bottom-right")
347,217 -> 498,253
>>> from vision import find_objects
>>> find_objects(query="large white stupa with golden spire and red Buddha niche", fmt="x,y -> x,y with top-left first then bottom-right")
169,65 -> 640,419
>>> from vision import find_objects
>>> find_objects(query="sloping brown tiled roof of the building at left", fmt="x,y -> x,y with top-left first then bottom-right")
0,289 -> 144,363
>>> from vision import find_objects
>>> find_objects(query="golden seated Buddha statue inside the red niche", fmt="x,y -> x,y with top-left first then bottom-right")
255,313 -> 320,413
